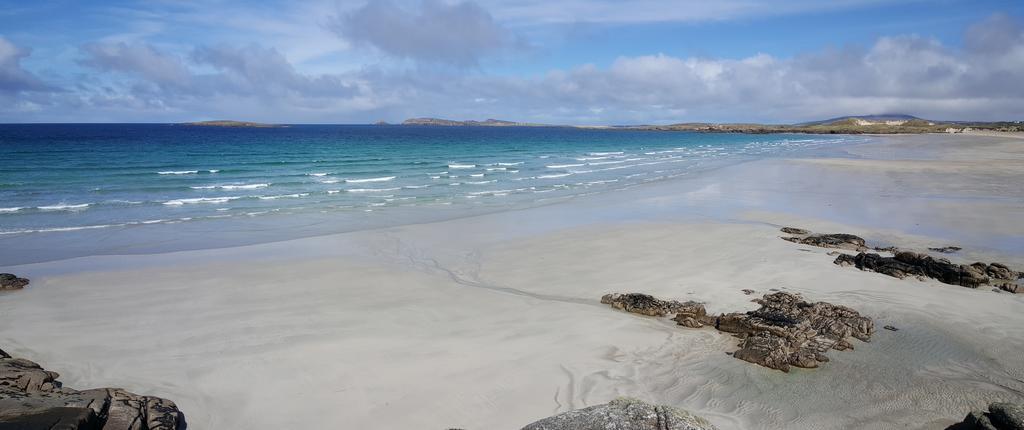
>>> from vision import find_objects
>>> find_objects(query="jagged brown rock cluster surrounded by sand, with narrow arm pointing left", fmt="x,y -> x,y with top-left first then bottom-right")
601,292 -> 874,372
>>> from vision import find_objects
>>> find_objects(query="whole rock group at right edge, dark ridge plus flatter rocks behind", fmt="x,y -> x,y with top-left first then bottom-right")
782,227 -> 1024,293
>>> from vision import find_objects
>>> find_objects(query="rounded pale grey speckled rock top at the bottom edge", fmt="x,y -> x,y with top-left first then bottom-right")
522,398 -> 716,430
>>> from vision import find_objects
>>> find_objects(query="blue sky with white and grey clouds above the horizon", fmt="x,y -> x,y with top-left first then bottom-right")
0,0 -> 1024,125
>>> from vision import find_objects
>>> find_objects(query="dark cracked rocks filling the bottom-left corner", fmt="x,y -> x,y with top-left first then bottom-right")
0,350 -> 185,430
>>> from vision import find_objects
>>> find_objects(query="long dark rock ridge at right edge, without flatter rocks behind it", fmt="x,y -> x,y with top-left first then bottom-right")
835,251 -> 1022,293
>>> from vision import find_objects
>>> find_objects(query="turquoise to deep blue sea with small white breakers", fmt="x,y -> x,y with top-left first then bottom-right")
0,124 -> 863,265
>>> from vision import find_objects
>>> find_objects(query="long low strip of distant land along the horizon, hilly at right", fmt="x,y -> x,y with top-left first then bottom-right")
401,114 -> 1024,134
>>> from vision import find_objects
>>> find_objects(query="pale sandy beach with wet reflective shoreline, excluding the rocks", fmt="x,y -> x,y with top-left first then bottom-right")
0,134 -> 1024,430
